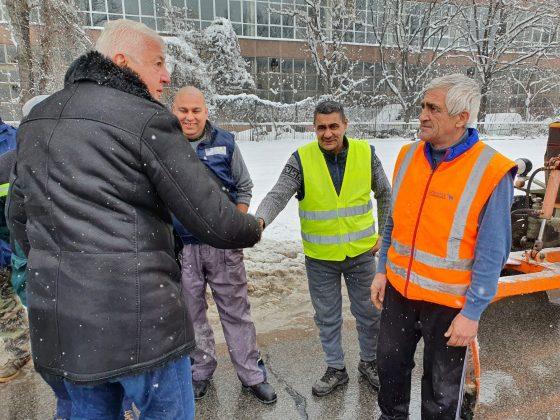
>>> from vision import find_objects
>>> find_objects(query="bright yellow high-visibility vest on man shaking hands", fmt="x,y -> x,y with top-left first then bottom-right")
298,139 -> 378,261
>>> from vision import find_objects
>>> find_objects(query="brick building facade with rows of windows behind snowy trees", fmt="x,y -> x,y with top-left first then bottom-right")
0,0 -> 548,119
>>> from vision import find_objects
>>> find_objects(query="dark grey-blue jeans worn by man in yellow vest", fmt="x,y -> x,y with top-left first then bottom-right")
305,251 -> 380,369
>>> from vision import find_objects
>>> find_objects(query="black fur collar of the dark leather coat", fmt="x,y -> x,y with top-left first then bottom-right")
64,51 -> 159,103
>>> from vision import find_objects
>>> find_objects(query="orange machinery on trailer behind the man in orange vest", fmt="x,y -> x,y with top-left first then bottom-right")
460,122 -> 560,419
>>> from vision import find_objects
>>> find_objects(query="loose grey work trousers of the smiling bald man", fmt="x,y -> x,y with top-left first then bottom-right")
182,244 -> 264,386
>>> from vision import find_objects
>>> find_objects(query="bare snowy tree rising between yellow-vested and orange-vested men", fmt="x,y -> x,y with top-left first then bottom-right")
368,0 -> 464,122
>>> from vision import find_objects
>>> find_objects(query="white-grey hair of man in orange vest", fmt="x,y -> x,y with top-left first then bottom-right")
425,73 -> 482,124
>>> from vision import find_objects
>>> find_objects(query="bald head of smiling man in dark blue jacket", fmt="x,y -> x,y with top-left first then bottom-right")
173,86 -> 208,140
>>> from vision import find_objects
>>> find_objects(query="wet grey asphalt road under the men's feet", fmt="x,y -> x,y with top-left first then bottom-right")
0,294 -> 560,419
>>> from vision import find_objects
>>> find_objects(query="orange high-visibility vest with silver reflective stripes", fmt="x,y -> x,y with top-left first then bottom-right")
387,141 -> 515,308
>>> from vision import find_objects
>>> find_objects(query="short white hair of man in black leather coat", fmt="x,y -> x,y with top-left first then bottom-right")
95,19 -> 165,59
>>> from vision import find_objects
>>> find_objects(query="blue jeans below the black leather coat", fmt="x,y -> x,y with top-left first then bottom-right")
64,356 -> 194,420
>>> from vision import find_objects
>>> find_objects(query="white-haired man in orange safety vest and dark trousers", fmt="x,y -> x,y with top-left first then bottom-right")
371,74 -> 516,419
